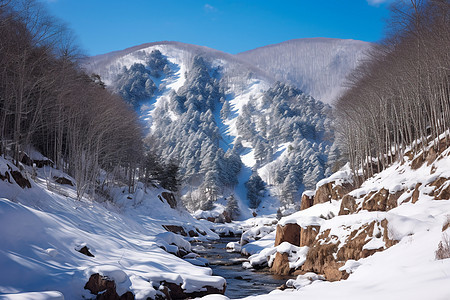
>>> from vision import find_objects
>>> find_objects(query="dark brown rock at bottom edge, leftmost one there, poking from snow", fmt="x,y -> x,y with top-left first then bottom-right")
84,273 -> 134,300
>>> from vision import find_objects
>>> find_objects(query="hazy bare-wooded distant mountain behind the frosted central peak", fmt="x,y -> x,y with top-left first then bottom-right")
237,38 -> 371,103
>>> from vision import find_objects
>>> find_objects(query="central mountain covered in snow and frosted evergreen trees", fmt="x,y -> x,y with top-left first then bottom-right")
85,42 -> 335,215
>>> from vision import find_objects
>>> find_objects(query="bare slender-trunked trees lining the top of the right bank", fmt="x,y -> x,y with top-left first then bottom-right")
335,0 -> 450,183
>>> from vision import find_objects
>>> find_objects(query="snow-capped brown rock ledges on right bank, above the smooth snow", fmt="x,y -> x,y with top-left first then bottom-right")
272,135 -> 450,281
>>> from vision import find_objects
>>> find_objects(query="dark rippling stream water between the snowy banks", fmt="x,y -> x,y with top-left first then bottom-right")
192,238 -> 293,299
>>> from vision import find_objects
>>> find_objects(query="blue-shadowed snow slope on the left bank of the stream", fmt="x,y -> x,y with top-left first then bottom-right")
0,158 -> 225,299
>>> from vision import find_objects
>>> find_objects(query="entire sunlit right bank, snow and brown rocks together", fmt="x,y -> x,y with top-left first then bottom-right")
230,135 -> 450,299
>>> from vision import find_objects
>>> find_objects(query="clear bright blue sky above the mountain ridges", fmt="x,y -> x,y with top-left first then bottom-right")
43,0 -> 389,55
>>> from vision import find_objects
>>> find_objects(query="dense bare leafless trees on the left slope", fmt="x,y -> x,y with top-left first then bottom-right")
0,0 -> 177,198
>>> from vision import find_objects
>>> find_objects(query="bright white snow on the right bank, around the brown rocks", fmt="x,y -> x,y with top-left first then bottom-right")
211,141 -> 450,300
